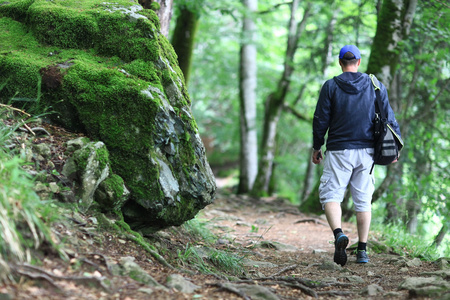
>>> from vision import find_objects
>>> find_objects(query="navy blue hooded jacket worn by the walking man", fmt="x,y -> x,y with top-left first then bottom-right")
313,72 -> 400,150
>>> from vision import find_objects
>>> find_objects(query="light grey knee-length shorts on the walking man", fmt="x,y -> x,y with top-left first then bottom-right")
319,148 -> 375,212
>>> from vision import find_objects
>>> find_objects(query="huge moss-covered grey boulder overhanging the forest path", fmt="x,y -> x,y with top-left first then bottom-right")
0,0 -> 215,231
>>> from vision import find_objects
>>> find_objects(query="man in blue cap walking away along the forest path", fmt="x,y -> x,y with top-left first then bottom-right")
312,45 -> 400,266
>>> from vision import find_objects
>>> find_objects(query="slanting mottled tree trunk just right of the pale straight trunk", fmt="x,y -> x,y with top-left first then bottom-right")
251,0 -> 311,196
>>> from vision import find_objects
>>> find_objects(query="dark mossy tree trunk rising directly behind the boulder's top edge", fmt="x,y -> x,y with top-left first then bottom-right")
172,6 -> 199,85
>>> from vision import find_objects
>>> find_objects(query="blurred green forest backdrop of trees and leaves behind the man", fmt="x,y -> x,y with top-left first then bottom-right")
170,0 -> 450,255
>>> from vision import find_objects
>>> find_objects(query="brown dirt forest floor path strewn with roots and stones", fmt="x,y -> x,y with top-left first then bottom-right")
0,118 -> 449,300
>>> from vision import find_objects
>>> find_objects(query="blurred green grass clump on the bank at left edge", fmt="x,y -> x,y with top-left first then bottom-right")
0,108 -> 56,280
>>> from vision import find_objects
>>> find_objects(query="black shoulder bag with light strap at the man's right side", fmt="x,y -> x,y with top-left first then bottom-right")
370,74 -> 403,174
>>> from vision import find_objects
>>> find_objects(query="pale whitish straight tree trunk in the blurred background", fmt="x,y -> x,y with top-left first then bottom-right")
238,0 -> 258,194
